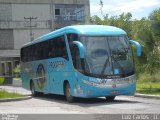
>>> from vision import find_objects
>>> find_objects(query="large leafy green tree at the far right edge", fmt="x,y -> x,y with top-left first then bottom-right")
132,10 -> 160,75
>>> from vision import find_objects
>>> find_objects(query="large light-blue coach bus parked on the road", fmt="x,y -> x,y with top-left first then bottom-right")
21,25 -> 142,102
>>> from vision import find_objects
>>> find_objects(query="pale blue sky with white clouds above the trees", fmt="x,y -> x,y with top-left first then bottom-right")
90,0 -> 160,19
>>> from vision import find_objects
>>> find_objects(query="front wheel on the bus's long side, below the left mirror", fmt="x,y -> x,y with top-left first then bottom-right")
65,83 -> 74,103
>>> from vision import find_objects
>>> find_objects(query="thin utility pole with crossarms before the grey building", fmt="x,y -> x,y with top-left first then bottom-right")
24,17 -> 37,41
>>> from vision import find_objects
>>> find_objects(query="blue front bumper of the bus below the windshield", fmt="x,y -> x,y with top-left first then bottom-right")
74,75 -> 136,98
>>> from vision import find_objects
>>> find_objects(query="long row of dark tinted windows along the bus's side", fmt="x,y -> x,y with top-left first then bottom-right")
21,36 -> 68,62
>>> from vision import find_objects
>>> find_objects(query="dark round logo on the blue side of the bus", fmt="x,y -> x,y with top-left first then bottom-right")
36,64 -> 46,89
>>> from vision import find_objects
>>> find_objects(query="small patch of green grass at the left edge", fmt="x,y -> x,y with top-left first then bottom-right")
0,90 -> 24,99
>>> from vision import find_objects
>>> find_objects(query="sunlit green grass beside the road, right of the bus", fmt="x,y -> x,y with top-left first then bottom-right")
136,73 -> 160,95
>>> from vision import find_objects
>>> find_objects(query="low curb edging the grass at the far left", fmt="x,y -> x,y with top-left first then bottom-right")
0,96 -> 32,102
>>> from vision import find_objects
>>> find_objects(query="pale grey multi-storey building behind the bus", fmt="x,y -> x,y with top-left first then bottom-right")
0,0 -> 90,76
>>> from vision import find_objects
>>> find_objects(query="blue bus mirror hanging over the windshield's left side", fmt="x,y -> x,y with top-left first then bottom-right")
73,41 -> 85,58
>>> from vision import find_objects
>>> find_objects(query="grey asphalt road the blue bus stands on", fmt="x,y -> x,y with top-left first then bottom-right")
0,88 -> 160,114
